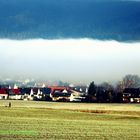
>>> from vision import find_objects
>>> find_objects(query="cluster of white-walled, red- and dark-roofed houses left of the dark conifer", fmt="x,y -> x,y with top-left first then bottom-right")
0,84 -> 88,102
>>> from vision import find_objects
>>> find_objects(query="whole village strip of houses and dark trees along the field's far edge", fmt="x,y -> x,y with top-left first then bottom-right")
0,82 -> 140,103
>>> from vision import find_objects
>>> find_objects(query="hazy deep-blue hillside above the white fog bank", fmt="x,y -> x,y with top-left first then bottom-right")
0,0 -> 140,41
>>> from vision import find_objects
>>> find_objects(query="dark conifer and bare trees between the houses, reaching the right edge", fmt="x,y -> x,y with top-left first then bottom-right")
87,74 -> 140,103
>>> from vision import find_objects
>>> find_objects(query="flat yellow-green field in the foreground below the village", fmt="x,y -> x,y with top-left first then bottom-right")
0,100 -> 140,140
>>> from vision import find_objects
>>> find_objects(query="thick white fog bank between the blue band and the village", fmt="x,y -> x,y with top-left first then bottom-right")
0,39 -> 140,82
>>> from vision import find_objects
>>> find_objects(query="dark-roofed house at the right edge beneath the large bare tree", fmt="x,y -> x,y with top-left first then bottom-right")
122,88 -> 140,103
